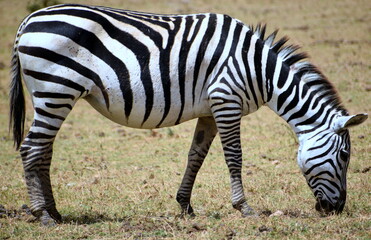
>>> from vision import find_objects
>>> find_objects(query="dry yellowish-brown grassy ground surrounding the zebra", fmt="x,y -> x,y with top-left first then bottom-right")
0,0 -> 371,239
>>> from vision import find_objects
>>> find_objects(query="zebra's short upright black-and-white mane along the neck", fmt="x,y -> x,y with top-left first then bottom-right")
250,24 -> 348,115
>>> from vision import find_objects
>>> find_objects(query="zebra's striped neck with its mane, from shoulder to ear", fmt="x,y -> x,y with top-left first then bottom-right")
244,25 -> 348,134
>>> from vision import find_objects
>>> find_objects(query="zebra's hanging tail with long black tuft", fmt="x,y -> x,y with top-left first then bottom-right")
9,31 -> 26,150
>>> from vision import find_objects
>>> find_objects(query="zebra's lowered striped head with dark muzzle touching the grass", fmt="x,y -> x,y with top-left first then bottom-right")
298,114 -> 367,214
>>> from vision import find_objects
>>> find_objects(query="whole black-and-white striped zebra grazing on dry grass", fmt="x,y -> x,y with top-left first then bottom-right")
10,5 -> 367,224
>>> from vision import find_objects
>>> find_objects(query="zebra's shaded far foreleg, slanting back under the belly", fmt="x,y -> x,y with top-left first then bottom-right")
176,117 -> 217,216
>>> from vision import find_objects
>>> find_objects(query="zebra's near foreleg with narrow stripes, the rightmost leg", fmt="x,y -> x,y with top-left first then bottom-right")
210,95 -> 255,217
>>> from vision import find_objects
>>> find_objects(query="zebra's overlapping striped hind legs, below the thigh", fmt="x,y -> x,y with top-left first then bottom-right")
20,101 -> 73,223
